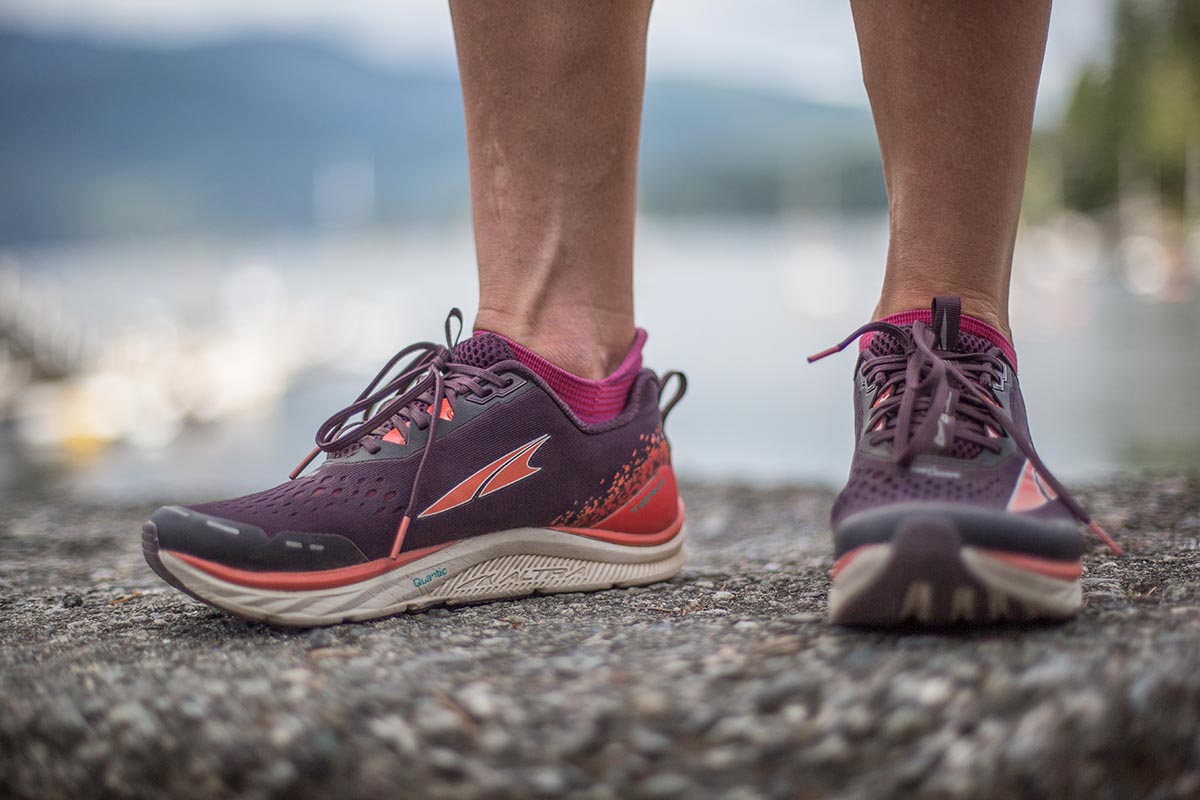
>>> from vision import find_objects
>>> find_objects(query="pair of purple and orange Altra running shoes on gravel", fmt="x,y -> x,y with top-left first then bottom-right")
143,297 -> 1120,626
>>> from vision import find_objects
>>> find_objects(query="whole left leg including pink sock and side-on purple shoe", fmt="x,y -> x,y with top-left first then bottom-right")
142,0 -> 686,626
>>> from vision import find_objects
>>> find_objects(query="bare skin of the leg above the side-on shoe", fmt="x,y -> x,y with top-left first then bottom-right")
450,0 -> 650,379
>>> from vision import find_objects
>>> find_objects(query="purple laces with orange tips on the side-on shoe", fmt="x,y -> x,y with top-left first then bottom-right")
289,308 -> 511,559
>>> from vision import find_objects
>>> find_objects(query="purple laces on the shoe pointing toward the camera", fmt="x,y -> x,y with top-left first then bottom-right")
809,320 -> 1122,555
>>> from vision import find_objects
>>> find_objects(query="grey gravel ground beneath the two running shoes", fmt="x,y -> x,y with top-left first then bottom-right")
0,475 -> 1200,799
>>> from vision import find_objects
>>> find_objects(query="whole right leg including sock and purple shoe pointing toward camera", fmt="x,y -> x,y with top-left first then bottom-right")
811,0 -> 1120,625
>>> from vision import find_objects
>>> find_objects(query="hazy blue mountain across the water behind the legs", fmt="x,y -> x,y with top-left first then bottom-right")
0,34 -> 883,242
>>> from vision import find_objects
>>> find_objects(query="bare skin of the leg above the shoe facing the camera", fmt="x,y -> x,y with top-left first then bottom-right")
851,0 -> 1050,337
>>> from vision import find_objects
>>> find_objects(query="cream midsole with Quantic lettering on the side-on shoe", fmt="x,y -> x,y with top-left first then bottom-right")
160,528 -> 684,625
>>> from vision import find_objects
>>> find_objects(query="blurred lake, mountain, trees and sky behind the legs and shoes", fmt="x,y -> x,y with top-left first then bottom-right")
0,0 -> 1200,501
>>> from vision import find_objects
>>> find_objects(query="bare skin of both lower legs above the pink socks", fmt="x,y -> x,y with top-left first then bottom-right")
450,0 -> 1050,357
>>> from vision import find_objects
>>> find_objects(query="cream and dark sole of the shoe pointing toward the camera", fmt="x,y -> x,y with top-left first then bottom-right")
829,516 -> 1082,627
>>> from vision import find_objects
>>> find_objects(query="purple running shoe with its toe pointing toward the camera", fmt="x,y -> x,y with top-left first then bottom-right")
809,297 -> 1121,626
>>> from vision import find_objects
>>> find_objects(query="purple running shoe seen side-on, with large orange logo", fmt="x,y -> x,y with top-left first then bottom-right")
143,309 -> 686,626
